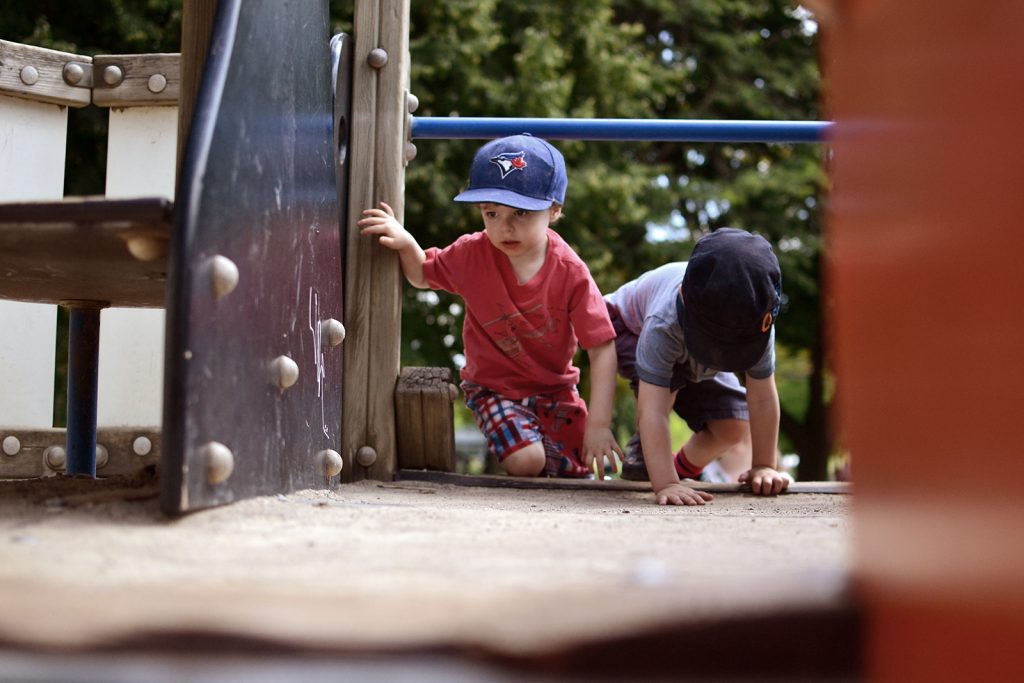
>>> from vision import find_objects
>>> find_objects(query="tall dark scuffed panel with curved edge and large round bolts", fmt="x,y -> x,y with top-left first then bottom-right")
161,0 -> 343,514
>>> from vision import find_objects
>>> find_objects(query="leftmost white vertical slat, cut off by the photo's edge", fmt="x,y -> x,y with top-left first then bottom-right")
0,95 -> 68,429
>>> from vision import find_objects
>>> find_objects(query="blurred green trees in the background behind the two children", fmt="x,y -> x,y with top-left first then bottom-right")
0,0 -> 834,479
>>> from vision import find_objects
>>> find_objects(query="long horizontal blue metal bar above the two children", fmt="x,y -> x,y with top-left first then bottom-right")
413,117 -> 833,142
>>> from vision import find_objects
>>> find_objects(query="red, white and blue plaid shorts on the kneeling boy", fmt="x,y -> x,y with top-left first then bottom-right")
462,382 -> 591,478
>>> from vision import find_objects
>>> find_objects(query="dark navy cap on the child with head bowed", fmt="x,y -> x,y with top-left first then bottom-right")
676,227 -> 782,373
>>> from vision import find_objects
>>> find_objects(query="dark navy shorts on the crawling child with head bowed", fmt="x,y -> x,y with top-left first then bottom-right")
608,304 -> 751,432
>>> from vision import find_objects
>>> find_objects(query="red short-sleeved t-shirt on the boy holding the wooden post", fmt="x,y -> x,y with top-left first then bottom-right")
423,228 -> 615,398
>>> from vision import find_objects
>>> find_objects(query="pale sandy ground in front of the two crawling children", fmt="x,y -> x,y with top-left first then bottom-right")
0,471 -> 851,667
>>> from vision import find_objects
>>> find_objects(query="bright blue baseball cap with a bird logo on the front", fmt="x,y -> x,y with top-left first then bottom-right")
455,133 -> 568,211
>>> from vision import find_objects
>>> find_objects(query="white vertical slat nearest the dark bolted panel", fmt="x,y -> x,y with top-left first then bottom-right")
96,106 -> 178,427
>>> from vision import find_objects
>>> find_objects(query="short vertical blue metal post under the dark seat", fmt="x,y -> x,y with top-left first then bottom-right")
67,306 -> 99,477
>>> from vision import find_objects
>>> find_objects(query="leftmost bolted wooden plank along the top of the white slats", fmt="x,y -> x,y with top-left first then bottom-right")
0,40 -> 92,106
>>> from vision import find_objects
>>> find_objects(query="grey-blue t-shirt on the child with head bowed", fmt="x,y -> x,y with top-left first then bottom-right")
604,261 -> 775,387
